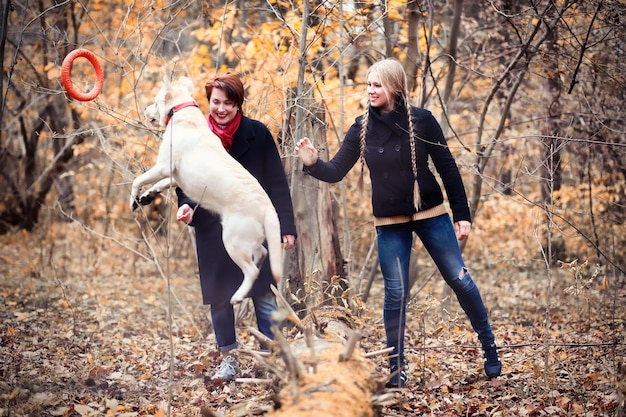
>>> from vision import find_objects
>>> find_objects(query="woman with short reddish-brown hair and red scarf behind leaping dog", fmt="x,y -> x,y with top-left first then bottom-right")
176,74 -> 296,381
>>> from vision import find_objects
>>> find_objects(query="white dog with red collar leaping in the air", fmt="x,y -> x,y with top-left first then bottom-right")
130,77 -> 282,304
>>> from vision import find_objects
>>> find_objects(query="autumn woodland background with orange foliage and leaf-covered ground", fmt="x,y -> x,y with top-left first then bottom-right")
0,0 -> 626,416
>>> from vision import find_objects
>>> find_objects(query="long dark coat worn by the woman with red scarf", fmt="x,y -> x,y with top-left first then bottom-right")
176,117 -> 296,304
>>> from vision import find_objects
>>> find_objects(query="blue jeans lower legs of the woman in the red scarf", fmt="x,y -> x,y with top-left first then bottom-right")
211,292 -> 277,352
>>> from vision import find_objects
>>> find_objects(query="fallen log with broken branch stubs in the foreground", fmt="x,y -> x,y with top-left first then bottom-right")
260,307 -> 380,417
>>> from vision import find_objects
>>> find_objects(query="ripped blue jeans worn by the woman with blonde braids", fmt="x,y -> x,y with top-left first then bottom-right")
376,214 -> 494,369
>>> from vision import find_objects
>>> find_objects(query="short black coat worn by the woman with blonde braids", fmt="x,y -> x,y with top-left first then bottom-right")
304,104 -> 471,222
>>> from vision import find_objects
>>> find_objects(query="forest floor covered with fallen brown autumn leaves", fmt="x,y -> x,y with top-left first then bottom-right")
0,219 -> 626,417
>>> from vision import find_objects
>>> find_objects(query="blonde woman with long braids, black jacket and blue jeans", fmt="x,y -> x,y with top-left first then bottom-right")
295,59 -> 502,387
